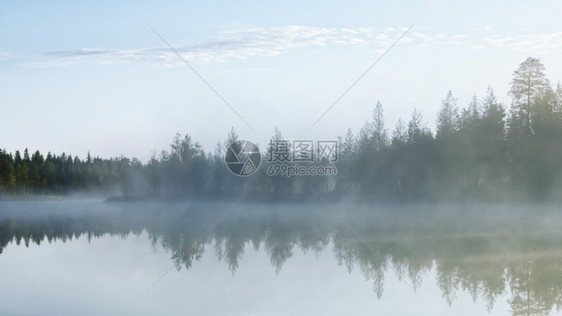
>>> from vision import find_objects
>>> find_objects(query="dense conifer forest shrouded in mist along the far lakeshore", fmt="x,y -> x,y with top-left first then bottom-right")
0,57 -> 562,201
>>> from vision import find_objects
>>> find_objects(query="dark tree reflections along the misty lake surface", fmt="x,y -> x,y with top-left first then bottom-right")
0,203 -> 562,315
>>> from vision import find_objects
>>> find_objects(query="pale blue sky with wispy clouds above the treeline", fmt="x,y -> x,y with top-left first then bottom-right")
0,1 -> 562,160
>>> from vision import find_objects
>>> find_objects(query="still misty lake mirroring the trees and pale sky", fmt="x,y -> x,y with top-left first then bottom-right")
0,199 -> 562,315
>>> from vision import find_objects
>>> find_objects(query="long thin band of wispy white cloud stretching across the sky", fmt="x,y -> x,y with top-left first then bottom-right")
6,25 -> 562,67
